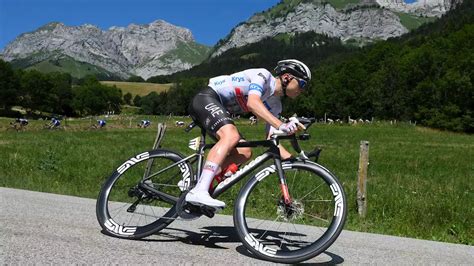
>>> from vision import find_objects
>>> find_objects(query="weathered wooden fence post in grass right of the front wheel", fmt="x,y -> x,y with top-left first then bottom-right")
357,140 -> 369,217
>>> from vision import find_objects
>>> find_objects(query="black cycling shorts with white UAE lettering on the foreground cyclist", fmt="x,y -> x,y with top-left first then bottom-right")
188,87 -> 234,139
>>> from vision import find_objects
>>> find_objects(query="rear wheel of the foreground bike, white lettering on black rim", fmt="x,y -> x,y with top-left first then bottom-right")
96,149 -> 193,239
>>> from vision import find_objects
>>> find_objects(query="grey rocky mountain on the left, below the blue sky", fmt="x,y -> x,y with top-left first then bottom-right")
3,20 -> 209,79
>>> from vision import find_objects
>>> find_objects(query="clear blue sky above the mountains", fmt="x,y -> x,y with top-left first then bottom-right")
0,0 -> 280,50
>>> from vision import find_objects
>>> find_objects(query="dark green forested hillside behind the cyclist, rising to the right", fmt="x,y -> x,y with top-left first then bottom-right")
149,1 -> 474,132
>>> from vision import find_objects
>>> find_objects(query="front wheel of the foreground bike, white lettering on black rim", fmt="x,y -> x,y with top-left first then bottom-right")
234,161 -> 347,263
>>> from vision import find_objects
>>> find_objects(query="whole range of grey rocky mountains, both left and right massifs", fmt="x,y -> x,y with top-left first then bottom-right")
0,0 -> 459,79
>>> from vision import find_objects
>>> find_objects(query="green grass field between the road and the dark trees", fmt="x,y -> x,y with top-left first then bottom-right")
0,116 -> 474,245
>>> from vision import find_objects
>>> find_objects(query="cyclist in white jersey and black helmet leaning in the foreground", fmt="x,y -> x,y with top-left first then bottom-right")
186,59 -> 311,210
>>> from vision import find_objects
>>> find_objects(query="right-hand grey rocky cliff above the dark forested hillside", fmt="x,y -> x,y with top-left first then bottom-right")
212,0 -> 462,57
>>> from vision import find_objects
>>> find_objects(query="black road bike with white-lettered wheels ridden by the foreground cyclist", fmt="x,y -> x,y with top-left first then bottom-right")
96,118 -> 347,263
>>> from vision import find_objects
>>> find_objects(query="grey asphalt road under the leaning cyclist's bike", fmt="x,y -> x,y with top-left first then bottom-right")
0,188 -> 474,265
